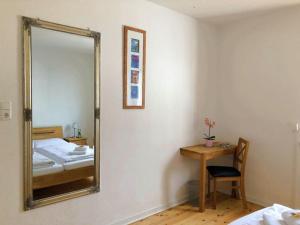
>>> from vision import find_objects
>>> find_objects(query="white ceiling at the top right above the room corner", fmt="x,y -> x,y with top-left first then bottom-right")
149,0 -> 300,23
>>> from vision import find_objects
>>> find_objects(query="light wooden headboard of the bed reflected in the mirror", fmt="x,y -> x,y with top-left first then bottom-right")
32,126 -> 63,140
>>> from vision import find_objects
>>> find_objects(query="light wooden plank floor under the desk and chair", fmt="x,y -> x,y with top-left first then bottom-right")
132,193 -> 263,225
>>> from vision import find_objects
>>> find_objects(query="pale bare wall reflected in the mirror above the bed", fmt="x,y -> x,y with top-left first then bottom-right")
32,28 -> 94,144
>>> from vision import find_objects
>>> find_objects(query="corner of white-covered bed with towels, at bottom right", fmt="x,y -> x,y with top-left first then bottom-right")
229,204 -> 300,225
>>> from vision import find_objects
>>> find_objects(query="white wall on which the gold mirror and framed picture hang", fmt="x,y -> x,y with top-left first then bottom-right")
0,0 -> 216,225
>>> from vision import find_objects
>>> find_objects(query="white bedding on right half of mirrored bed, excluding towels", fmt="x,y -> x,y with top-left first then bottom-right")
35,142 -> 94,164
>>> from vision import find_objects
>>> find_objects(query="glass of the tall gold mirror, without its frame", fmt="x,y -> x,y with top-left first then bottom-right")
31,26 -> 95,200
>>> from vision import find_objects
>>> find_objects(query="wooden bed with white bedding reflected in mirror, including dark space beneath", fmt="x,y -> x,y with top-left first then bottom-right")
32,127 -> 94,200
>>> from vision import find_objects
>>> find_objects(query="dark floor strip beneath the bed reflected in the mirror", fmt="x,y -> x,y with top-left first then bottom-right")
33,177 -> 93,200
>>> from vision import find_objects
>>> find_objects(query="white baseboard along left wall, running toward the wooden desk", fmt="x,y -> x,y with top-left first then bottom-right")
108,196 -> 189,225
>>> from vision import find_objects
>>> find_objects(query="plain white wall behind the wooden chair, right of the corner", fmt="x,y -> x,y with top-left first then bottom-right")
216,7 -> 300,205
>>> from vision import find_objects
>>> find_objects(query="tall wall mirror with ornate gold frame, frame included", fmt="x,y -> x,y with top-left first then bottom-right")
23,17 -> 100,209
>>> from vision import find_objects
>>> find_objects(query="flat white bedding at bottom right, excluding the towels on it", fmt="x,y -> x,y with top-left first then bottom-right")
229,204 -> 291,225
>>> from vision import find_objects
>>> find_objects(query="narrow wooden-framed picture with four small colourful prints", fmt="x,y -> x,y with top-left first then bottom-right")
123,26 -> 146,109
